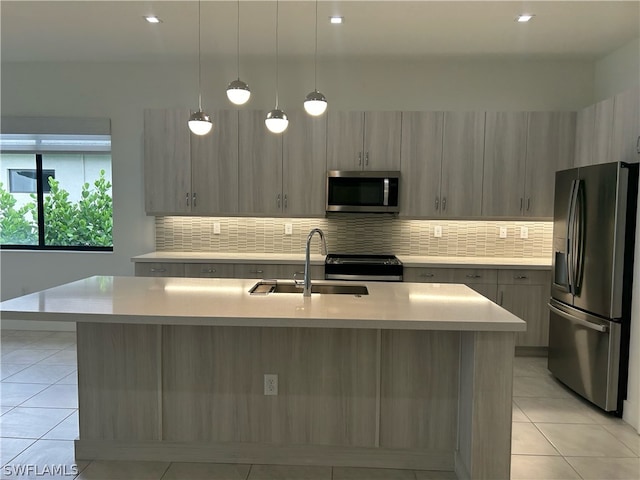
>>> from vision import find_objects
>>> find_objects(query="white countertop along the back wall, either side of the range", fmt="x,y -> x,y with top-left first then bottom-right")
131,252 -> 551,270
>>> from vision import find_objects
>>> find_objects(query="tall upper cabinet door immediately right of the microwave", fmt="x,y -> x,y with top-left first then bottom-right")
400,112 -> 444,217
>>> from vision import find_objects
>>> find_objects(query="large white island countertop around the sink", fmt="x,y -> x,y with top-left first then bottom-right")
0,276 -> 526,332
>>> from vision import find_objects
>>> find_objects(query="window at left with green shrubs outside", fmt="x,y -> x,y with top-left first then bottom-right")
0,118 -> 113,251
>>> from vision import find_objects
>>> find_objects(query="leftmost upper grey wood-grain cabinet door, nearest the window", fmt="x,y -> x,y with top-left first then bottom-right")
144,109 -> 191,215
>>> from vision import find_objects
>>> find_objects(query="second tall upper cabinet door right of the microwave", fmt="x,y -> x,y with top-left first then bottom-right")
440,112 -> 484,217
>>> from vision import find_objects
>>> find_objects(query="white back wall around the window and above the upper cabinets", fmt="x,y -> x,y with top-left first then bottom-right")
0,58 -> 593,327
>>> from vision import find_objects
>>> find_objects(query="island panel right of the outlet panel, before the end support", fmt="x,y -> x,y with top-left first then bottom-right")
380,330 -> 460,458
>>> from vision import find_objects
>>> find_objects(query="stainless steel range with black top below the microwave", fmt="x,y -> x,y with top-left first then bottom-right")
324,253 -> 403,282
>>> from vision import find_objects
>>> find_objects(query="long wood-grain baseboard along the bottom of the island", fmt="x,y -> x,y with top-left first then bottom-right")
75,440 -> 454,472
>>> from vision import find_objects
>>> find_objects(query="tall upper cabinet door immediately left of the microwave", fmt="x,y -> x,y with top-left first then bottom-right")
282,111 -> 327,216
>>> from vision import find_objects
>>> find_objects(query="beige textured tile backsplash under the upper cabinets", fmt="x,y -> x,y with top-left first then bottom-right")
156,215 -> 553,258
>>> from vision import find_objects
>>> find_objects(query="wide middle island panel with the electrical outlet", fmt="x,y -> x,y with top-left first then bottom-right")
163,326 -> 377,447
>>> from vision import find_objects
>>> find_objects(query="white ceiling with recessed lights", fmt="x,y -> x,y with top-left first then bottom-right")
0,0 -> 640,62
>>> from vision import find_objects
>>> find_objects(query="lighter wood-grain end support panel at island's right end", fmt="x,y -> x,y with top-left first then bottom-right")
455,332 -> 515,480
